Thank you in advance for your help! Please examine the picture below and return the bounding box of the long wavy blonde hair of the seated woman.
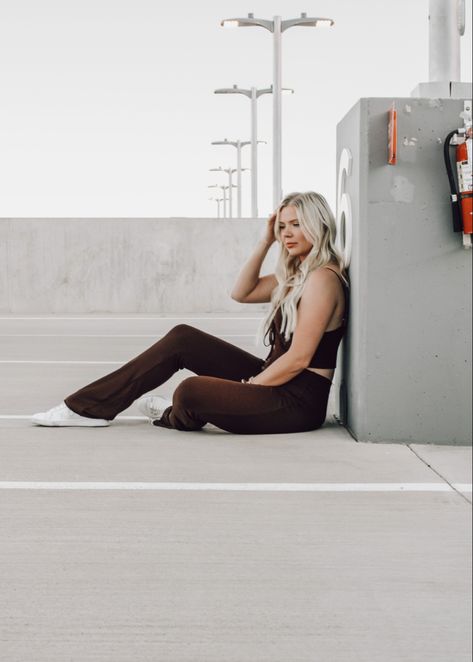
[257,191,349,344]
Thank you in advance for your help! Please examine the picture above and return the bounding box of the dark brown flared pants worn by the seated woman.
[65,324,331,434]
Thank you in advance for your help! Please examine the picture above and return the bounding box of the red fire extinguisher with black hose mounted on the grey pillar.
[443,102,473,248]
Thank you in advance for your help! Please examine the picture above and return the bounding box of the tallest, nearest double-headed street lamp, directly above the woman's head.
[220,13,335,207]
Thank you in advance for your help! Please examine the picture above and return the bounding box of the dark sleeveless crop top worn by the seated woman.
[263,267,349,369]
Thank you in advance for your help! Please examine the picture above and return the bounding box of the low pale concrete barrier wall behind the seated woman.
[0,218,279,314]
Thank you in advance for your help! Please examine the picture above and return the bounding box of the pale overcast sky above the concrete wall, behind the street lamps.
[0,0,472,217]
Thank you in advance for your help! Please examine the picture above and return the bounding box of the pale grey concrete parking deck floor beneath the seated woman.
[0,315,471,662]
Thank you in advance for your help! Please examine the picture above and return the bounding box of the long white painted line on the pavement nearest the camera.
[0,481,471,492]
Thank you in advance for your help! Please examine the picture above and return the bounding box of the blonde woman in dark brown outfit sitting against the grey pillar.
[32,192,349,434]
